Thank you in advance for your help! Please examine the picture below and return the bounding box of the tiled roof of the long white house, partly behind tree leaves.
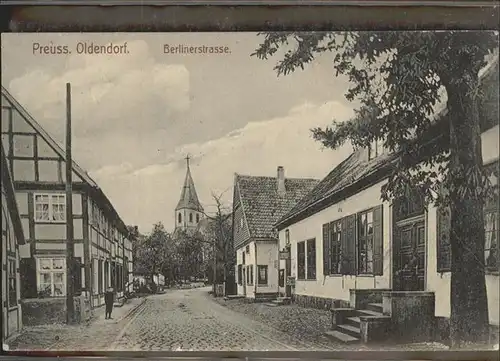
[276,58,498,228]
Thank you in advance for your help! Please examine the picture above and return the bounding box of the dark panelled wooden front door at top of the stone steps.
[393,220,425,291]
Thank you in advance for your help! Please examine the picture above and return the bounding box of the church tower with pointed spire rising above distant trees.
[175,156,204,233]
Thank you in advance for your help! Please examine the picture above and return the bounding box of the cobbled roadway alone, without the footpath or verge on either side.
[111,288,309,351]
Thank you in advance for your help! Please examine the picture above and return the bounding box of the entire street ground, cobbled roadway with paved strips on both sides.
[9,288,454,351]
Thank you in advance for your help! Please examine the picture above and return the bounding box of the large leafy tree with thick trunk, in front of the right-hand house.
[252,31,498,345]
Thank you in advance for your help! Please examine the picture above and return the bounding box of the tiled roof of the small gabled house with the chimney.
[235,174,319,238]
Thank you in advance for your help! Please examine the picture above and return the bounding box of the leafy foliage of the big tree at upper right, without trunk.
[252,31,498,208]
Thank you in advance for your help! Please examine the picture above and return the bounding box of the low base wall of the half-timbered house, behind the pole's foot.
[21,296,92,326]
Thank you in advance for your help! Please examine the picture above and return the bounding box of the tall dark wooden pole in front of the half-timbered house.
[66,83,75,324]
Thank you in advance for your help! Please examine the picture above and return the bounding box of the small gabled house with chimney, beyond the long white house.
[233,167,318,299]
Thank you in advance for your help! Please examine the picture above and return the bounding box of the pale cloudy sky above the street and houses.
[2,33,354,233]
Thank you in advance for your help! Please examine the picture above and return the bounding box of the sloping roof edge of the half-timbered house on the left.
[2,85,128,235]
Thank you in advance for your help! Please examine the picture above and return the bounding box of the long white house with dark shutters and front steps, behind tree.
[277,57,499,342]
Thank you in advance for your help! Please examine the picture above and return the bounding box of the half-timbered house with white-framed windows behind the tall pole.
[1,87,133,307]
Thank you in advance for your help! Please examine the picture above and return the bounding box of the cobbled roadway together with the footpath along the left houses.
[9,288,325,351]
